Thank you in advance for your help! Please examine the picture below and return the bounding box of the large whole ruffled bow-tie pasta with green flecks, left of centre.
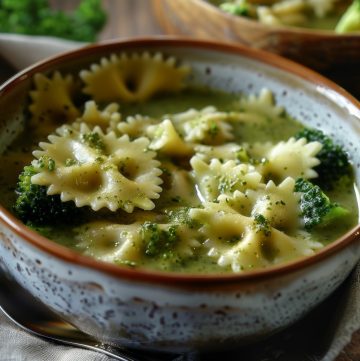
[31,123,162,213]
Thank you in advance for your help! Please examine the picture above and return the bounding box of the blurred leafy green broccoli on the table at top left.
[0,0,106,42]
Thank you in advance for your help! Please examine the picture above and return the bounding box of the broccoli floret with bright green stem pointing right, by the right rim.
[294,178,349,230]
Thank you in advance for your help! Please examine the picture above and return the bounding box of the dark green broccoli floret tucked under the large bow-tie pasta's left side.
[14,165,81,227]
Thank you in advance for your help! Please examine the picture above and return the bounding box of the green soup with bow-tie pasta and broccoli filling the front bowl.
[4,53,357,273]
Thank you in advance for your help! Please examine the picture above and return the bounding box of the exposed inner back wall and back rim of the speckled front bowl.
[0,39,360,282]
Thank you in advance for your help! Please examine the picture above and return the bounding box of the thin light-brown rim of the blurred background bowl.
[193,0,360,40]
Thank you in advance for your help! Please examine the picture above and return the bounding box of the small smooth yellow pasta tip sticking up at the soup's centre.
[146,119,193,157]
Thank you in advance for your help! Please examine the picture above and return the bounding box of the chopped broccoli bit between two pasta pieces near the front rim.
[140,222,179,259]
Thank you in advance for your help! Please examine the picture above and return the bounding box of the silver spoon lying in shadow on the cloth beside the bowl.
[0,273,179,361]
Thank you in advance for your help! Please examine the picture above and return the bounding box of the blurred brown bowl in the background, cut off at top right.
[153,0,360,71]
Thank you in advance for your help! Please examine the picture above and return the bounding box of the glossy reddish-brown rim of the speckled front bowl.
[0,36,360,287]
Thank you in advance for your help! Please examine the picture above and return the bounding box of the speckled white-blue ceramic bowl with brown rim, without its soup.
[0,39,360,351]
